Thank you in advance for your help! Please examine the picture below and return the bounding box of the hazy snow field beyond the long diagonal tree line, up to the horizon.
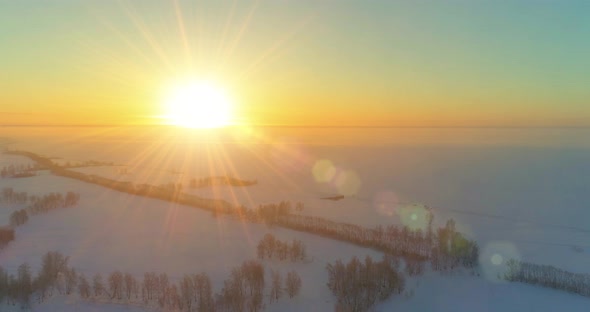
[53,146,590,272]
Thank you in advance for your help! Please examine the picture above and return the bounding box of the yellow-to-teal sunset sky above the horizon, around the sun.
[0,0,590,127]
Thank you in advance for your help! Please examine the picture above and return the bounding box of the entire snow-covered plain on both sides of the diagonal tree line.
[0,126,590,311]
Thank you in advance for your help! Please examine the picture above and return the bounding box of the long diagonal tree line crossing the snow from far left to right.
[5,152,479,274]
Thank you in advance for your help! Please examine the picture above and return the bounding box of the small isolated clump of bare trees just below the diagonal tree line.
[256,233,307,262]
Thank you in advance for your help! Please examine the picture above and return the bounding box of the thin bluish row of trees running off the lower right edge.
[504,259,590,297]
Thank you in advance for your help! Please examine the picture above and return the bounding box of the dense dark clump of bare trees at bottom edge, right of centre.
[326,256,405,312]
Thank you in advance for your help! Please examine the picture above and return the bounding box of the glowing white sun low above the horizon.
[164,81,232,128]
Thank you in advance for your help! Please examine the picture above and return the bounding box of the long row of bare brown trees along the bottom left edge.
[0,252,301,312]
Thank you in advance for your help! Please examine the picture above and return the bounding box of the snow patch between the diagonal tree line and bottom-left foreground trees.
[0,175,380,311]
